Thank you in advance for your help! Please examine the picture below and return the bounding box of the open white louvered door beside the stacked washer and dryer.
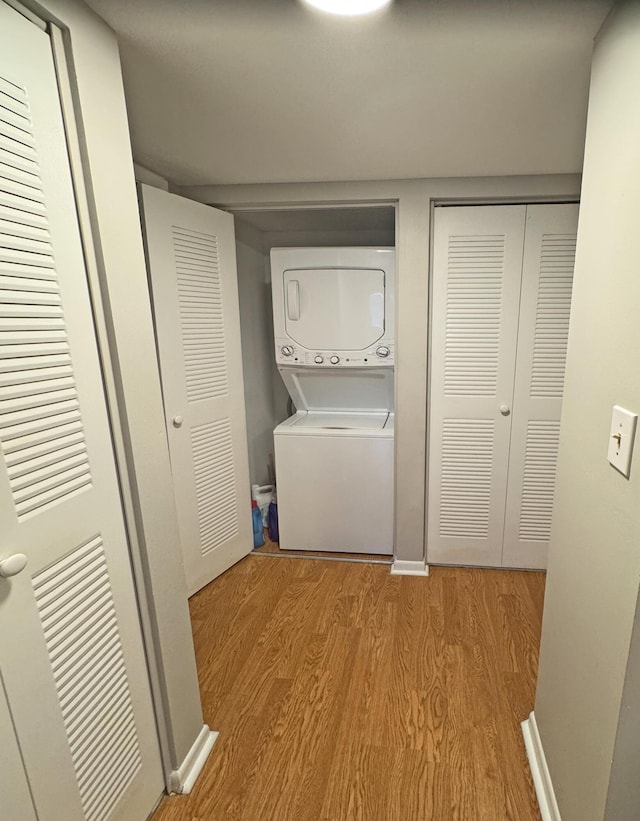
[141,185,253,594]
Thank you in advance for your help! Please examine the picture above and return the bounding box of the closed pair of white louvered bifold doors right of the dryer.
[427,204,578,568]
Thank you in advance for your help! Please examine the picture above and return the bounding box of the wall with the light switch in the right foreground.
[535,1,640,821]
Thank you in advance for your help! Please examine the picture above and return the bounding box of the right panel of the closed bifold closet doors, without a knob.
[502,204,578,568]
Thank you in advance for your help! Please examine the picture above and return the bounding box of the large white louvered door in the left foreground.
[0,3,163,821]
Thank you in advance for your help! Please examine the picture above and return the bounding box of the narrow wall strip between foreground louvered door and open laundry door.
[26,0,202,780]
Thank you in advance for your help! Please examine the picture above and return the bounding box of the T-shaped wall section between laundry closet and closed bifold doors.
[177,175,579,561]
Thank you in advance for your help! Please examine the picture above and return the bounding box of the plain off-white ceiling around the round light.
[86,0,612,185]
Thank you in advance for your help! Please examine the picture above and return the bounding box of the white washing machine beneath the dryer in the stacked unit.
[274,369,394,555]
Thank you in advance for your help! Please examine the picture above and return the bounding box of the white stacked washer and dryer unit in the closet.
[271,248,395,554]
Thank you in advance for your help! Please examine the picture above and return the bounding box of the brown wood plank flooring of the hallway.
[153,555,544,821]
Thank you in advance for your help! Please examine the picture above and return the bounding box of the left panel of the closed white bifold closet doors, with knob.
[427,206,526,566]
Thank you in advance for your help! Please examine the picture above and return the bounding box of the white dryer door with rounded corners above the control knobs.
[283,268,385,351]
